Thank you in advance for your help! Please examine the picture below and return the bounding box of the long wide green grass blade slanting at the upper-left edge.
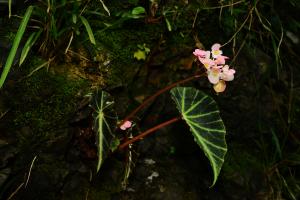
[0,6,33,88]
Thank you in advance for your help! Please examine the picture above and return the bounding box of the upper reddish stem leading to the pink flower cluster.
[119,73,205,127]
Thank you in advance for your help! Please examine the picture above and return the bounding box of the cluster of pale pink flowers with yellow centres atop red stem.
[193,44,235,92]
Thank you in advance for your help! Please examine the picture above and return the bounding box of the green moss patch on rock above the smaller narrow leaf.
[96,21,161,85]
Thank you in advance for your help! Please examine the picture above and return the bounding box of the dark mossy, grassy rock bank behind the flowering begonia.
[0,0,300,200]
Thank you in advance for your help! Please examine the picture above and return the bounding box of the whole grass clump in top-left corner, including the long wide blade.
[0,1,104,88]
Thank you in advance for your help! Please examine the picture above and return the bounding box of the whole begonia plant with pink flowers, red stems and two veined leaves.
[91,43,235,186]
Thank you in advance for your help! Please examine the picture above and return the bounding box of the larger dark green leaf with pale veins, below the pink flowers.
[171,87,227,186]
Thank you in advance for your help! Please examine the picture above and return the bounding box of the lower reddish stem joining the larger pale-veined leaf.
[119,117,181,149]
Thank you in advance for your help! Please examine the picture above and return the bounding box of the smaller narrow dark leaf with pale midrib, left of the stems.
[91,91,117,172]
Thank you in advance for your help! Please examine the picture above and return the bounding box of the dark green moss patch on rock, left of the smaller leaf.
[12,57,88,148]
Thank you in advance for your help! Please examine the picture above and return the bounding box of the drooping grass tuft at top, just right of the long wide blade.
[20,0,100,64]
